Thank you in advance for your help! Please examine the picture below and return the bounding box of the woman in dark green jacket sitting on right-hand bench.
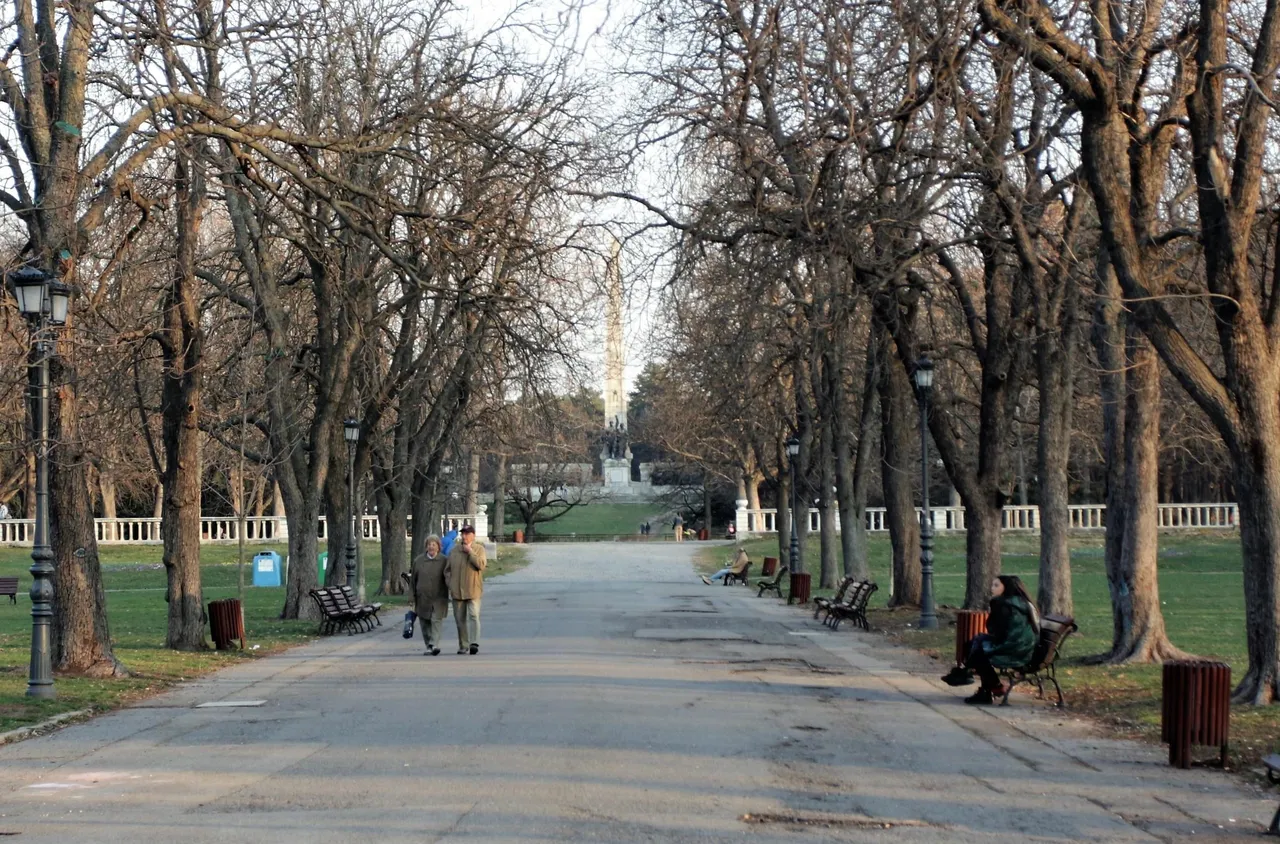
[942,575,1039,703]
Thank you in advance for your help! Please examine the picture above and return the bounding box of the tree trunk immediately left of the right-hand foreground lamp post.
[878,336,920,607]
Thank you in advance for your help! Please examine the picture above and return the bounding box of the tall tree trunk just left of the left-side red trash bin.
[160,154,207,651]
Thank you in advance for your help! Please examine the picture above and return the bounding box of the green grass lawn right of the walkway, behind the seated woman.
[701,532,1280,767]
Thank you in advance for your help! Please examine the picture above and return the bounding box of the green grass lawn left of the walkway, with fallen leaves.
[0,543,527,733]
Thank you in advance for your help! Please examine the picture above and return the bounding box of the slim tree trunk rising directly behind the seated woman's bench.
[1036,308,1075,616]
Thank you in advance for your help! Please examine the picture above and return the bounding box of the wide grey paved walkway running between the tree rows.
[0,543,1274,844]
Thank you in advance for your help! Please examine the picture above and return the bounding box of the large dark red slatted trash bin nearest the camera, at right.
[1160,660,1231,768]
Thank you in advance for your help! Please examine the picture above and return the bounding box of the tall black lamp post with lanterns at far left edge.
[9,266,72,698]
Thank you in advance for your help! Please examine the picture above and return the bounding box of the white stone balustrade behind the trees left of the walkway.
[0,505,489,546]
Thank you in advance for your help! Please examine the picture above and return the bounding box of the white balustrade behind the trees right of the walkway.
[735,501,1240,534]
